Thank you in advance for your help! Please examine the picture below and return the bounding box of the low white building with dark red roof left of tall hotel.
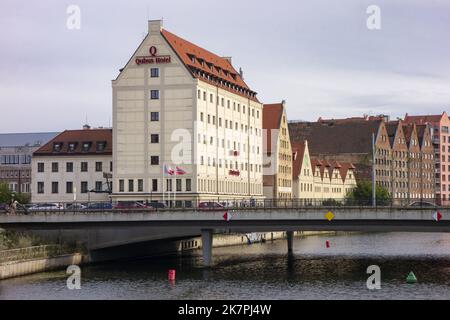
[31,126,113,203]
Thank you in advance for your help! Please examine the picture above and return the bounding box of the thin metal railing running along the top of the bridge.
[0,197,441,214]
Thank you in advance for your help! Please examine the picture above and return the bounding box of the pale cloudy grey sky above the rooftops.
[0,0,450,133]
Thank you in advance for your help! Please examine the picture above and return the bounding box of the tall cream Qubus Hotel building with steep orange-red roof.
[112,20,263,206]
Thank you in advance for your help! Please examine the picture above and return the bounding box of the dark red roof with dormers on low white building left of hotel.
[33,129,112,156]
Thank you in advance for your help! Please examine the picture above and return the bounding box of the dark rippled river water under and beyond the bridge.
[0,233,450,300]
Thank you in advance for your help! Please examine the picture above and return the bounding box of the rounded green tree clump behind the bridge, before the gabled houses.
[345,181,391,205]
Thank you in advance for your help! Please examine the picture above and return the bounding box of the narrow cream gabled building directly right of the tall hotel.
[263,101,292,199]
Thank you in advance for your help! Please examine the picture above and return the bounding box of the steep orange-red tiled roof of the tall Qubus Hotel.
[161,29,258,101]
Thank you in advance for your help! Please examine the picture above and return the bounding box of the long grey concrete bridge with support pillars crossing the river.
[0,206,450,266]
